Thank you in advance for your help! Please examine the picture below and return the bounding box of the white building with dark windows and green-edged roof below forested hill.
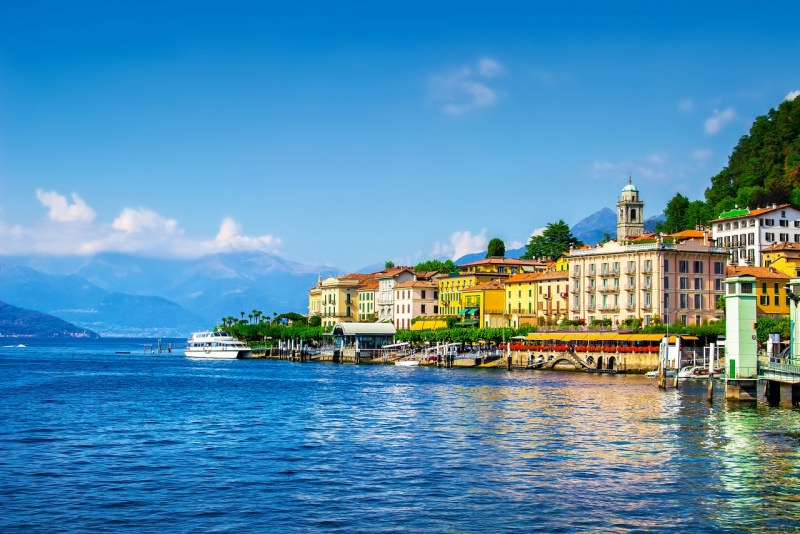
[711,204,800,266]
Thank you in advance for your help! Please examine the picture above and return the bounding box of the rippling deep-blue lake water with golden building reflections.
[0,339,800,532]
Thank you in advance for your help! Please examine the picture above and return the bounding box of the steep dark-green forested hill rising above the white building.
[659,96,800,231]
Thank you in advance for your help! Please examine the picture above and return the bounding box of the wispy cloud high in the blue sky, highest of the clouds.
[431,58,504,115]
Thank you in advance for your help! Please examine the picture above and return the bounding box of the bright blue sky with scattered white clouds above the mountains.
[0,0,800,272]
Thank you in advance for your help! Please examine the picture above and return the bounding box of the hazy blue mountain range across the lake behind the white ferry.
[0,252,334,337]
